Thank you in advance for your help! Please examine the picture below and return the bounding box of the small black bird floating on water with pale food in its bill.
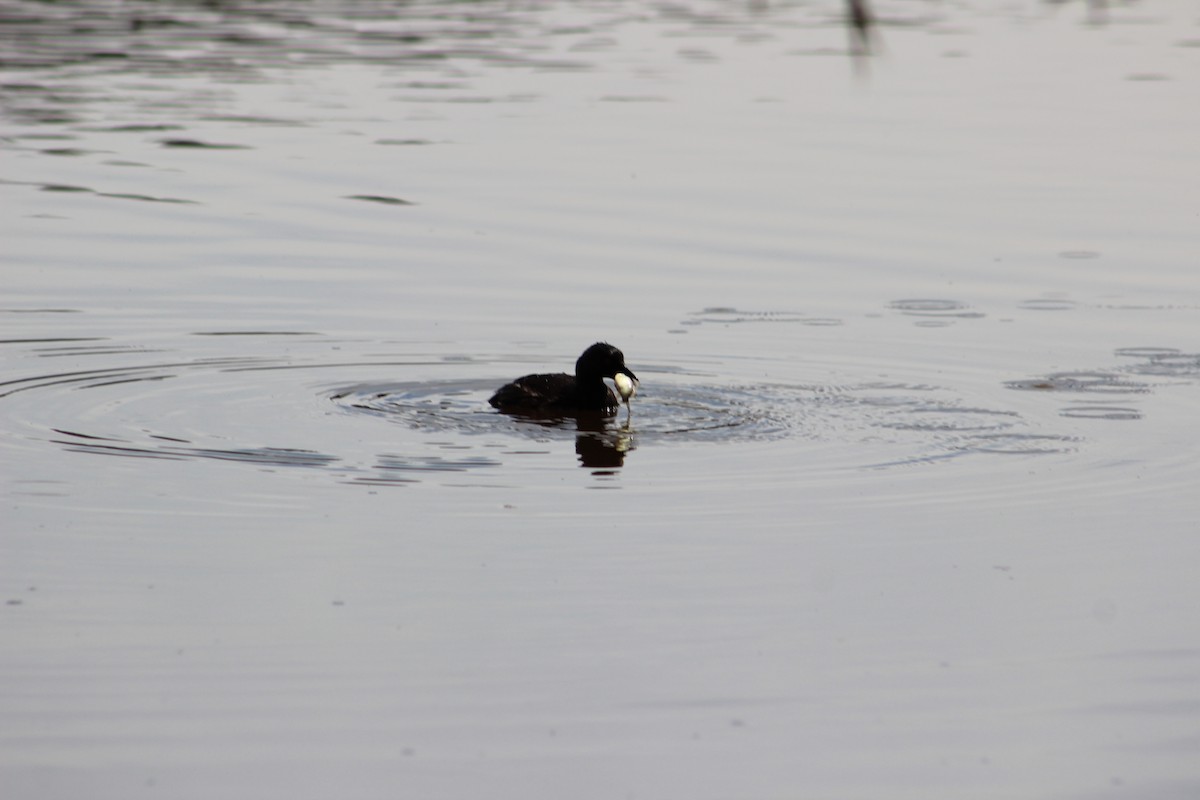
[487,342,637,414]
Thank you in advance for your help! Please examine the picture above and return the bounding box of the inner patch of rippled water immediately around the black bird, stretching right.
[326,371,1078,468]
